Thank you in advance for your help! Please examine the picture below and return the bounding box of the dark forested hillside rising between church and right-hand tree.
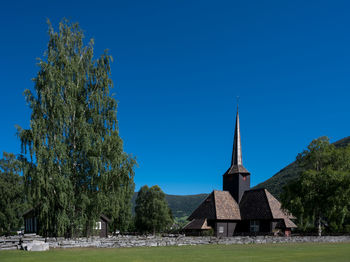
[254,136,350,198]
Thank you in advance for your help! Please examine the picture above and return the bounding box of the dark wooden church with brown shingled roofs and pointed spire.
[184,109,296,237]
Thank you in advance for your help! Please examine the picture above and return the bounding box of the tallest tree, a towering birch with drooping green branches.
[18,20,135,236]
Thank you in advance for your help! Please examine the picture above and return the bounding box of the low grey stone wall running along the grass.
[0,235,350,250]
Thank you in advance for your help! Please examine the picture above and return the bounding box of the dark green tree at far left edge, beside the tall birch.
[0,152,27,235]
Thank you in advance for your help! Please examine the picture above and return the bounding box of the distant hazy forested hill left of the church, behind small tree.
[132,192,208,218]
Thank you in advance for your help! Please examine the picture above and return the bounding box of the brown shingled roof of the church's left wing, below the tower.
[188,190,241,220]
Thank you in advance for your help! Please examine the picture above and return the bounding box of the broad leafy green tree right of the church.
[281,137,350,234]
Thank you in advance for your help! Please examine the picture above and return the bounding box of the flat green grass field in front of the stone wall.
[0,243,350,262]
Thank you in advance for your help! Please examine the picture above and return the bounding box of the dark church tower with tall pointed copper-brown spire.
[223,107,250,203]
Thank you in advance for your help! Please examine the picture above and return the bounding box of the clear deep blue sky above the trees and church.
[0,0,350,194]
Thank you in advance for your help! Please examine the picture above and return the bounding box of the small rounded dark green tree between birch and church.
[135,186,173,234]
